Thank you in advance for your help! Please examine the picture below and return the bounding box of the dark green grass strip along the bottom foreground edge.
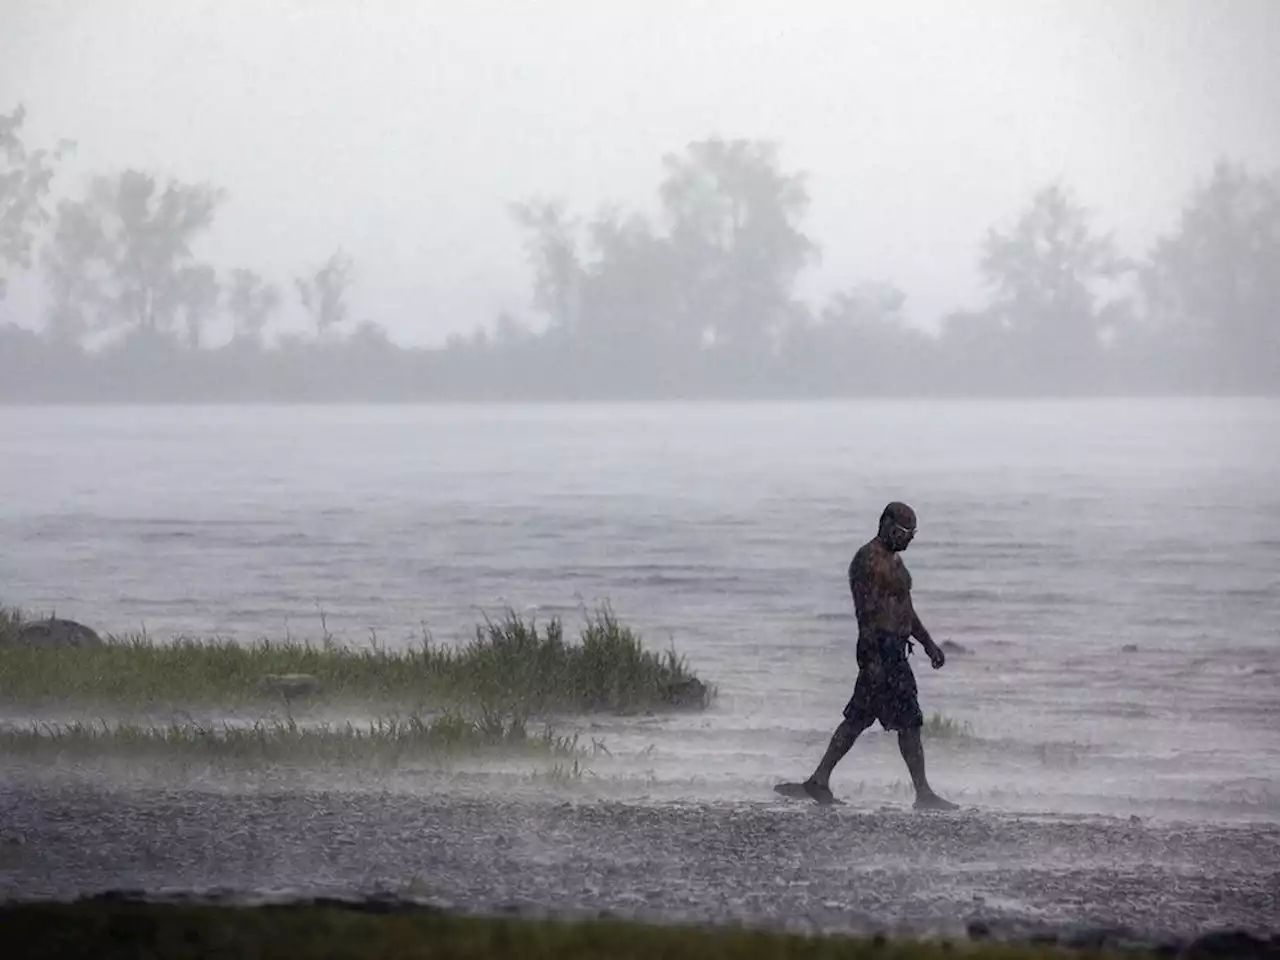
[0,899,1137,960]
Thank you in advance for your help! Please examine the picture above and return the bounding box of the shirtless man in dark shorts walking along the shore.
[804,503,959,810]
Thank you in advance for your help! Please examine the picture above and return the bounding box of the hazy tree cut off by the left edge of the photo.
[0,105,72,300]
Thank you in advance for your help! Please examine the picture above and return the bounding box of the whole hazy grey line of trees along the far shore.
[0,106,1280,401]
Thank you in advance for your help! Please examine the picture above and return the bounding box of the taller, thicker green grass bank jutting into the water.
[0,607,709,714]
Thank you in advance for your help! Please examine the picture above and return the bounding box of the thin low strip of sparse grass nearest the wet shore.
[0,713,581,767]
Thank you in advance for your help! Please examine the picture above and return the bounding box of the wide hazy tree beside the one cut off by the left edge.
[45,170,224,343]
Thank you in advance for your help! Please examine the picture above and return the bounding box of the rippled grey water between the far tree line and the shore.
[0,401,1280,820]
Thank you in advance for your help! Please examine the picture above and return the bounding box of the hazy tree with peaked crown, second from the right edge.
[979,183,1130,383]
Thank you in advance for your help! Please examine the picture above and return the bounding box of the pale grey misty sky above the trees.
[0,0,1280,343]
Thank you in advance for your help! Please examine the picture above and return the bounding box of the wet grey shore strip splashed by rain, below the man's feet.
[0,778,1280,942]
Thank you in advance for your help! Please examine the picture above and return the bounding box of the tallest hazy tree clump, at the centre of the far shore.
[511,138,817,372]
